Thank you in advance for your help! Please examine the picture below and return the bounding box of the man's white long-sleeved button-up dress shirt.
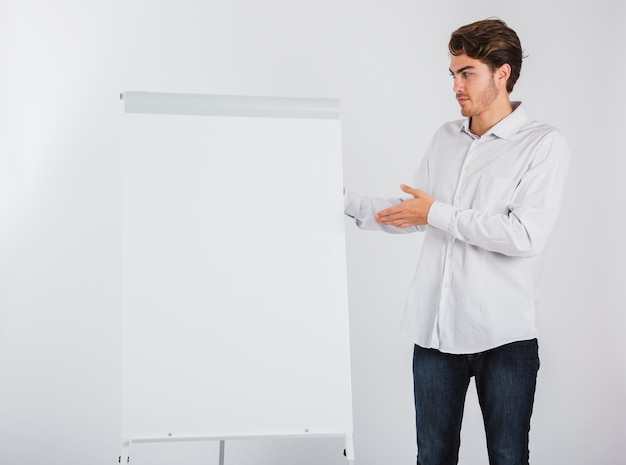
[345,102,569,354]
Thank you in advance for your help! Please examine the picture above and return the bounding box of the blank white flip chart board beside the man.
[122,92,352,440]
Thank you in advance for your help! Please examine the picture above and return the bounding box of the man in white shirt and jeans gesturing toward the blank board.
[345,19,569,465]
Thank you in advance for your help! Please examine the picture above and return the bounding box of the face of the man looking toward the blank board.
[450,55,500,116]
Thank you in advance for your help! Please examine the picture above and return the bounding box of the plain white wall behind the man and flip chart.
[0,0,626,465]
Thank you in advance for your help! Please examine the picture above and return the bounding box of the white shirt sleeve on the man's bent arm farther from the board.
[428,131,569,257]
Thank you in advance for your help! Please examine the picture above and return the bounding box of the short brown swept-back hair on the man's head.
[448,18,524,93]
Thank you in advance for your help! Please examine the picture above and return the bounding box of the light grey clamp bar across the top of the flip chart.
[120,91,339,119]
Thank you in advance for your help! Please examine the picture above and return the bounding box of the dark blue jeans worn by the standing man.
[413,339,539,465]
